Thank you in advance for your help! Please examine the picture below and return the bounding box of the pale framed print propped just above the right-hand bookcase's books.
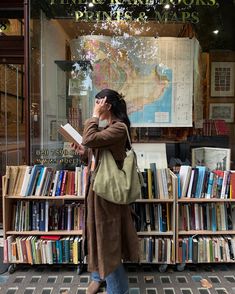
[192,147,231,170]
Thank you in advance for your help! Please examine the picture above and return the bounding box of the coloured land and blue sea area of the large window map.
[74,36,194,126]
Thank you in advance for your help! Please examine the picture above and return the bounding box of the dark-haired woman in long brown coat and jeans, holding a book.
[73,89,139,294]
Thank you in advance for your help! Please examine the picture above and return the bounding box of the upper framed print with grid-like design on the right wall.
[211,62,235,97]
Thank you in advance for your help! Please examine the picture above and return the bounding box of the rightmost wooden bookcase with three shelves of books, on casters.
[176,167,235,271]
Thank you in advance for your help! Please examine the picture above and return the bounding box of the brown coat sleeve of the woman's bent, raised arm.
[82,118,126,148]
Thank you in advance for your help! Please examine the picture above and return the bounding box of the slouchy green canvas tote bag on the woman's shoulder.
[93,124,143,204]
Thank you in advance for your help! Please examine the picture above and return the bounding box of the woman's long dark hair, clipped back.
[95,89,131,149]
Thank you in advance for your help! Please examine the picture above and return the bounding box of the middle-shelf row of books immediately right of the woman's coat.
[133,203,172,232]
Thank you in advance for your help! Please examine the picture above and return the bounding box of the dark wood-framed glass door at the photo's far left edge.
[0,64,25,223]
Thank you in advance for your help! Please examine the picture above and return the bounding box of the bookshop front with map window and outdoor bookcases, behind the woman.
[0,0,235,271]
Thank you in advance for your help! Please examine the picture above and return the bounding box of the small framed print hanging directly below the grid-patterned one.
[209,103,234,122]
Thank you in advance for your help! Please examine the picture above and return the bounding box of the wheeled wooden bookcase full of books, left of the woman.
[3,165,85,273]
